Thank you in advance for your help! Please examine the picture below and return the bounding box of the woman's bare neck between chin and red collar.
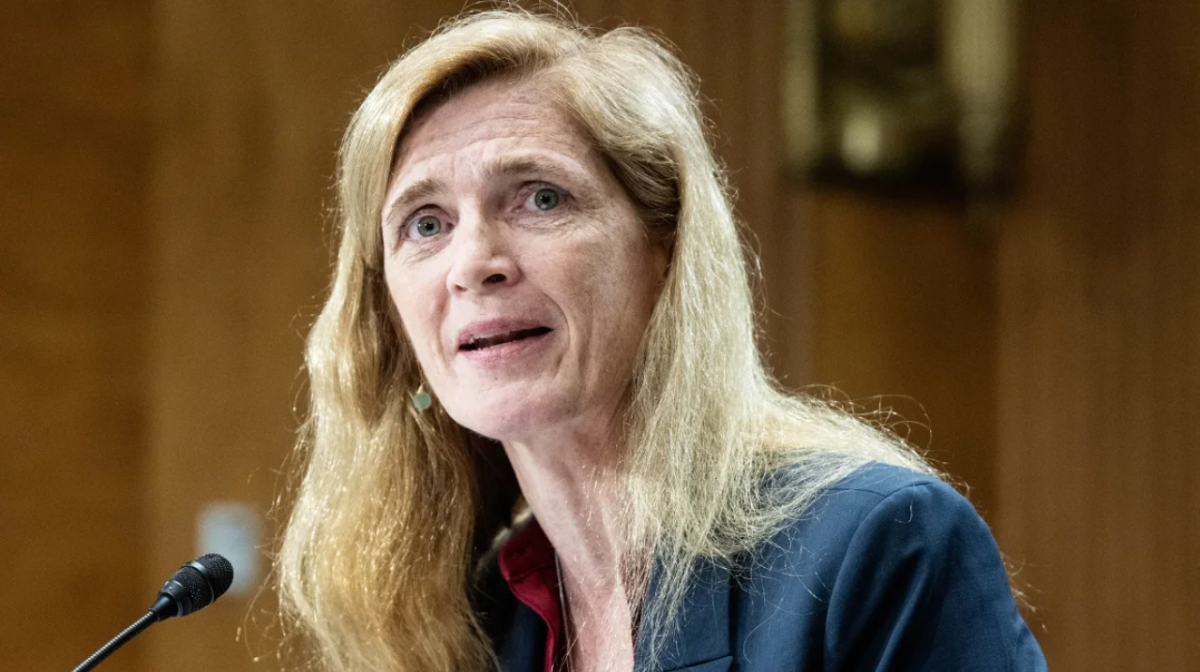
[504,420,632,672]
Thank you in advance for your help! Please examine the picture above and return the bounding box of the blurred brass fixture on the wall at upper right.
[782,0,1018,193]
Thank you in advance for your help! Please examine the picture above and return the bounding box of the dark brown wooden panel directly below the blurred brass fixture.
[801,190,997,513]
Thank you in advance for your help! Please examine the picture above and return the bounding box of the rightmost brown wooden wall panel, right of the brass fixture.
[997,0,1200,672]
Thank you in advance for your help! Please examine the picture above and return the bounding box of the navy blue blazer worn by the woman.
[485,464,1046,672]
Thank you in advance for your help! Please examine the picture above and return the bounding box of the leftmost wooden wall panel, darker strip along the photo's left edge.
[0,0,158,672]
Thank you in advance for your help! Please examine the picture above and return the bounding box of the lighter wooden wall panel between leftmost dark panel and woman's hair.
[146,0,458,672]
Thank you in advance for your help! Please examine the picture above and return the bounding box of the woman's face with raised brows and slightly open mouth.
[382,78,667,440]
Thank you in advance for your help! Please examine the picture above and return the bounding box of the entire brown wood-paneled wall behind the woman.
[0,0,1200,672]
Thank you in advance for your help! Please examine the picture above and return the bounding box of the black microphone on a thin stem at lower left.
[74,553,233,672]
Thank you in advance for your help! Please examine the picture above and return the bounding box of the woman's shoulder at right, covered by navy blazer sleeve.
[724,464,1044,670]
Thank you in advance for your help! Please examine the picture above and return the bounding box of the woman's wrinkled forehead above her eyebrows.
[392,79,599,186]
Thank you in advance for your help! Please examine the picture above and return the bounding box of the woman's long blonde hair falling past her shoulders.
[276,10,932,672]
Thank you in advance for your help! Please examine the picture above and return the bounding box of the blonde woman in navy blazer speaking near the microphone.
[278,6,1044,672]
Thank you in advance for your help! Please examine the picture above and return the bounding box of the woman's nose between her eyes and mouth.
[446,212,521,294]
